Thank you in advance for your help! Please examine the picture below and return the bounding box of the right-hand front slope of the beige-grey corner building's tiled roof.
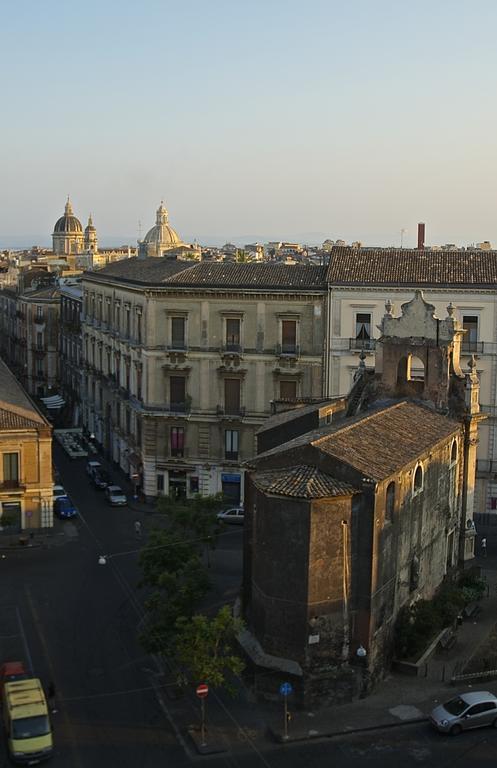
[168,262,327,291]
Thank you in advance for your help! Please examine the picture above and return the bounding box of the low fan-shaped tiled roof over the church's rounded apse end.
[252,464,357,499]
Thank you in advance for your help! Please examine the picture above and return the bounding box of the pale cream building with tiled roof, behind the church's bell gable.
[324,247,497,520]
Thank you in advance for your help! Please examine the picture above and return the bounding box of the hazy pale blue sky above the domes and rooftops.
[0,0,497,247]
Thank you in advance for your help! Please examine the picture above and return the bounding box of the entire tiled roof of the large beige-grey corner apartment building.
[84,257,327,291]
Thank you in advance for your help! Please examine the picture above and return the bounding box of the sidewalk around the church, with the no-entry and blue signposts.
[167,557,497,753]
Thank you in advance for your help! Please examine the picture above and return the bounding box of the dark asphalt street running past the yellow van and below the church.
[0,454,497,768]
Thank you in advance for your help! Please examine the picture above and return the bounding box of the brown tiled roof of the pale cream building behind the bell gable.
[327,247,497,288]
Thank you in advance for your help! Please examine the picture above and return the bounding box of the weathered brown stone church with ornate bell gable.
[242,291,482,705]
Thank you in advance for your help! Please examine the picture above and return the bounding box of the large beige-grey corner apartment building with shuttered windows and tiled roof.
[82,258,326,502]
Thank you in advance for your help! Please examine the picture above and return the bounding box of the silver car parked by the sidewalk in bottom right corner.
[430,691,497,736]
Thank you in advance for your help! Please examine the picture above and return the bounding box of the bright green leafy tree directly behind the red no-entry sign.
[175,605,245,692]
